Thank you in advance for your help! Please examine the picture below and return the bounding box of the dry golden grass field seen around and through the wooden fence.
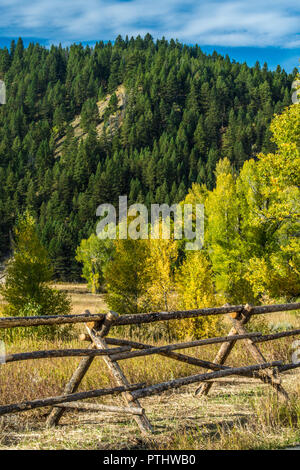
[0,284,300,450]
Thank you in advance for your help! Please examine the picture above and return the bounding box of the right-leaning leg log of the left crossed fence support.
[85,325,153,435]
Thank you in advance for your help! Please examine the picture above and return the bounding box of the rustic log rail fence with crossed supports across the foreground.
[0,303,300,433]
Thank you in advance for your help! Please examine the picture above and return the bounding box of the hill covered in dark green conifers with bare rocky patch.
[0,35,296,279]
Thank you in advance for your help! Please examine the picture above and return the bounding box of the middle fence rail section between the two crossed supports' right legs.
[111,333,261,361]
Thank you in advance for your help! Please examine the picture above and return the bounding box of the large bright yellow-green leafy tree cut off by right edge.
[240,104,300,299]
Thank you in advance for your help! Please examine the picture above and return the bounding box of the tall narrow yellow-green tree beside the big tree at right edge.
[205,158,252,303]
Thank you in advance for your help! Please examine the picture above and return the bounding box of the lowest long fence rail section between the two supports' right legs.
[131,361,282,399]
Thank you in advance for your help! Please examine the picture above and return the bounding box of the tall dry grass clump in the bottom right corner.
[161,385,300,450]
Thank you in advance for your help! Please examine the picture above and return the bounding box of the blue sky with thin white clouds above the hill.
[0,0,300,71]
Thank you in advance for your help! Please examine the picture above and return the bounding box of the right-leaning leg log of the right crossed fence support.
[231,318,289,400]
